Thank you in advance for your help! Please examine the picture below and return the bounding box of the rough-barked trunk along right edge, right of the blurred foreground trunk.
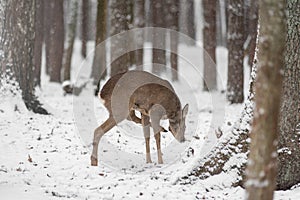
[272,0,300,190]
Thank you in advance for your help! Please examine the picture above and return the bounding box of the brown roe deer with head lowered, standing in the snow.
[91,71,188,166]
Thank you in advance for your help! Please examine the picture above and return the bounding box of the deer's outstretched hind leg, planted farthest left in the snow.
[91,116,116,166]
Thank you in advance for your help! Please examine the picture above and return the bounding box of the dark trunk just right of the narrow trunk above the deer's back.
[151,0,166,75]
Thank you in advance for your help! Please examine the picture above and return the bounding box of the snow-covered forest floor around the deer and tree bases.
[0,41,300,200]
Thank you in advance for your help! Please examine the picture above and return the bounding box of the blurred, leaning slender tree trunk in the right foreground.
[245,0,288,200]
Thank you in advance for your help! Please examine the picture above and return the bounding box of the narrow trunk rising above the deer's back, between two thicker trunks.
[134,0,145,70]
